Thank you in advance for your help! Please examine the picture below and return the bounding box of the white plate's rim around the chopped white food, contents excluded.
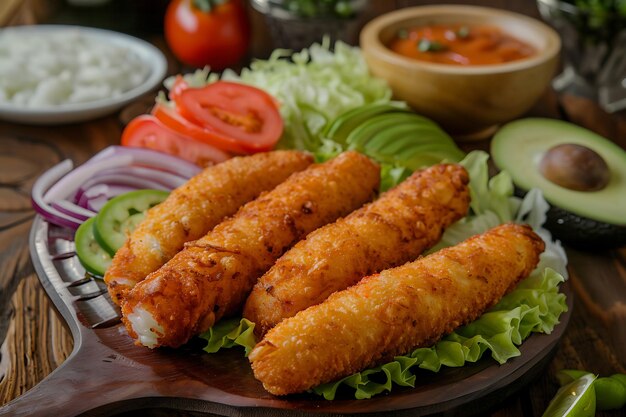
[0,25,167,125]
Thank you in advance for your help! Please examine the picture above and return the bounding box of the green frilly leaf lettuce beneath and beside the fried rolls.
[201,151,567,400]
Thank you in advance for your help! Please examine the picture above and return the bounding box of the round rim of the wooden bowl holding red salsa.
[360,4,561,75]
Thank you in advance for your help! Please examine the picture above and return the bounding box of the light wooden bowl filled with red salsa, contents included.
[360,5,561,140]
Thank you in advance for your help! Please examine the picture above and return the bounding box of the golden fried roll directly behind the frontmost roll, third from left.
[243,165,470,336]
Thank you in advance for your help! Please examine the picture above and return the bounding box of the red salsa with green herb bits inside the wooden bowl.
[389,24,536,65]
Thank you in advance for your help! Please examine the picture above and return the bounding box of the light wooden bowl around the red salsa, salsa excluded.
[360,5,561,140]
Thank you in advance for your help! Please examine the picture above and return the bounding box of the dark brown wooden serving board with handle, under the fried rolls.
[0,217,573,417]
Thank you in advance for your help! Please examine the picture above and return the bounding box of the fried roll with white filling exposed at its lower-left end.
[122,152,380,347]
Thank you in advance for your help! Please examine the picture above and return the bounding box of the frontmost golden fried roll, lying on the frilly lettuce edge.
[249,224,544,395]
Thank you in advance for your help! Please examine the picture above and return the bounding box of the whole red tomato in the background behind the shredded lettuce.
[165,0,250,70]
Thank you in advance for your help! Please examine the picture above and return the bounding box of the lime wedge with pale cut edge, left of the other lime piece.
[543,374,596,417]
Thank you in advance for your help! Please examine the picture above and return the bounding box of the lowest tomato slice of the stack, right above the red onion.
[122,114,230,167]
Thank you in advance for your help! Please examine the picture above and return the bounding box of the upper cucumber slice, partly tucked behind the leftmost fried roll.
[94,190,169,256]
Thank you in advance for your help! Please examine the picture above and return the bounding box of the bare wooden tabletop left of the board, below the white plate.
[0,127,114,404]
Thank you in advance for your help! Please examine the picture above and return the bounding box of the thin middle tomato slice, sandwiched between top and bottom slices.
[152,103,250,154]
